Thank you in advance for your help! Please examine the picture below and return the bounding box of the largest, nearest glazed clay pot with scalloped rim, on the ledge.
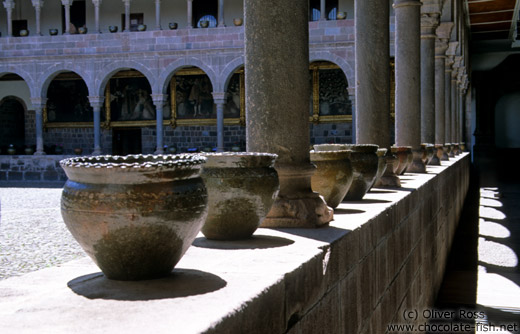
[60,155,207,280]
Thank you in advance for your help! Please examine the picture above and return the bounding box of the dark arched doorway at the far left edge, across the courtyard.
[0,97,25,154]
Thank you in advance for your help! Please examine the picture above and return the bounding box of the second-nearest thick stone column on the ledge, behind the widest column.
[353,0,401,187]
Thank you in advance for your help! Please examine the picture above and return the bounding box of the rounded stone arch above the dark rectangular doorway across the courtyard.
[95,60,156,96]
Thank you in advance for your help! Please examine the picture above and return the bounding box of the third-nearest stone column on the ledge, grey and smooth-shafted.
[394,0,426,173]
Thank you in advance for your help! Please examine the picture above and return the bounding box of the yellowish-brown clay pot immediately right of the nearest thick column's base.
[310,150,353,208]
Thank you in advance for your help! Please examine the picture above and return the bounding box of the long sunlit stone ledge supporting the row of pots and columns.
[0,153,469,334]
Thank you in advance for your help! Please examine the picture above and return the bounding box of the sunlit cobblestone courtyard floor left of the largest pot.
[0,188,85,280]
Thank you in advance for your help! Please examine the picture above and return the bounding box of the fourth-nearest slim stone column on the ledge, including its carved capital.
[421,1,440,144]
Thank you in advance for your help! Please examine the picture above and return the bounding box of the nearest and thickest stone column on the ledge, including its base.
[244,0,333,227]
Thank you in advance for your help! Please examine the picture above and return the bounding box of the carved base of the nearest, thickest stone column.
[260,164,334,228]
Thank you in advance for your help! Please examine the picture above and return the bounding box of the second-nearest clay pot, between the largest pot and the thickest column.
[202,152,279,240]
